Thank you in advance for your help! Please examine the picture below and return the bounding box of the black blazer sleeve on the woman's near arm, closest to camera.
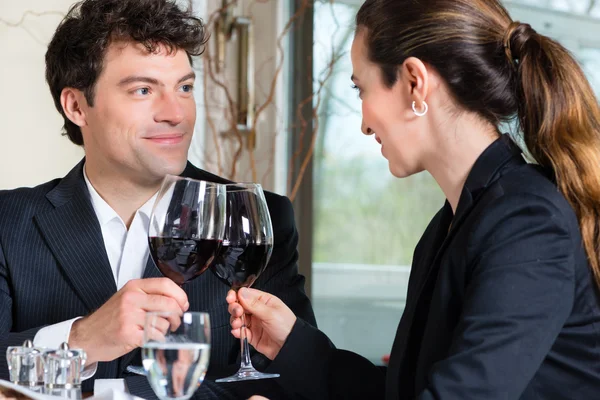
[418,194,577,400]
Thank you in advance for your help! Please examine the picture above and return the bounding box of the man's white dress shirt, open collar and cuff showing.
[33,166,157,379]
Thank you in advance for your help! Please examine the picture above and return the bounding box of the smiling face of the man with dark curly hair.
[81,41,196,184]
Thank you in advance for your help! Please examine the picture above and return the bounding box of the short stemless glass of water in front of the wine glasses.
[142,312,210,400]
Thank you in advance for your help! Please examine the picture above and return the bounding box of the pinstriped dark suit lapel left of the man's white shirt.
[35,161,117,311]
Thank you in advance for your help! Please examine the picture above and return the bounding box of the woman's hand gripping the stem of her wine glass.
[227,288,296,360]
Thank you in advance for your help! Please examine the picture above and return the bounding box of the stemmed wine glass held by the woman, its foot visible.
[210,183,279,382]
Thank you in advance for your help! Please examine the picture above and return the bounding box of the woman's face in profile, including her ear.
[351,29,429,178]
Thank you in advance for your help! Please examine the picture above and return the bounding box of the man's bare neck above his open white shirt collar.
[84,163,161,229]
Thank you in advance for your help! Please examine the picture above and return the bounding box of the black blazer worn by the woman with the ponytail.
[269,136,600,400]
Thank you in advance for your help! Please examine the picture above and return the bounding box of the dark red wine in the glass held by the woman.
[210,244,273,290]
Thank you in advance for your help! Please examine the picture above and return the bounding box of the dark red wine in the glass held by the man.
[148,237,221,285]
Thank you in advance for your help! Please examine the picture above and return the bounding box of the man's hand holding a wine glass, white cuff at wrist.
[69,278,189,364]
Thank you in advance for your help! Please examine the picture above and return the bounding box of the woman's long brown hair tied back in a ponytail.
[356,0,600,285]
